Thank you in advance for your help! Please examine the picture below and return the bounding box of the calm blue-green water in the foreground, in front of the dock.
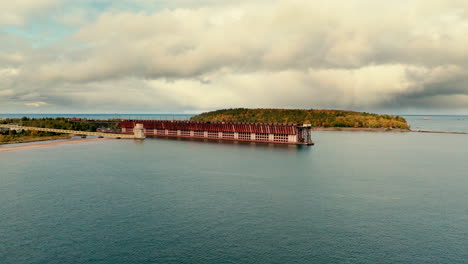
[0,132,468,264]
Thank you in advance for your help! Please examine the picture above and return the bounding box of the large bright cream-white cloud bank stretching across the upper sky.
[33,0,468,81]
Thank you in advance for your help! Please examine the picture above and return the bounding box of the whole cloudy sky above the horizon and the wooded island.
[0,0,468,114]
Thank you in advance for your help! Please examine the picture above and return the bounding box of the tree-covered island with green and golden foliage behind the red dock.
[191,108,409,129]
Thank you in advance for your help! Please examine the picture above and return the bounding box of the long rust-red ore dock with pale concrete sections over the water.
[120,120,313,145]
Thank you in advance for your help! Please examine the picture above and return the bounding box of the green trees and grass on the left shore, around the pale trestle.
[0,117,119,144]
